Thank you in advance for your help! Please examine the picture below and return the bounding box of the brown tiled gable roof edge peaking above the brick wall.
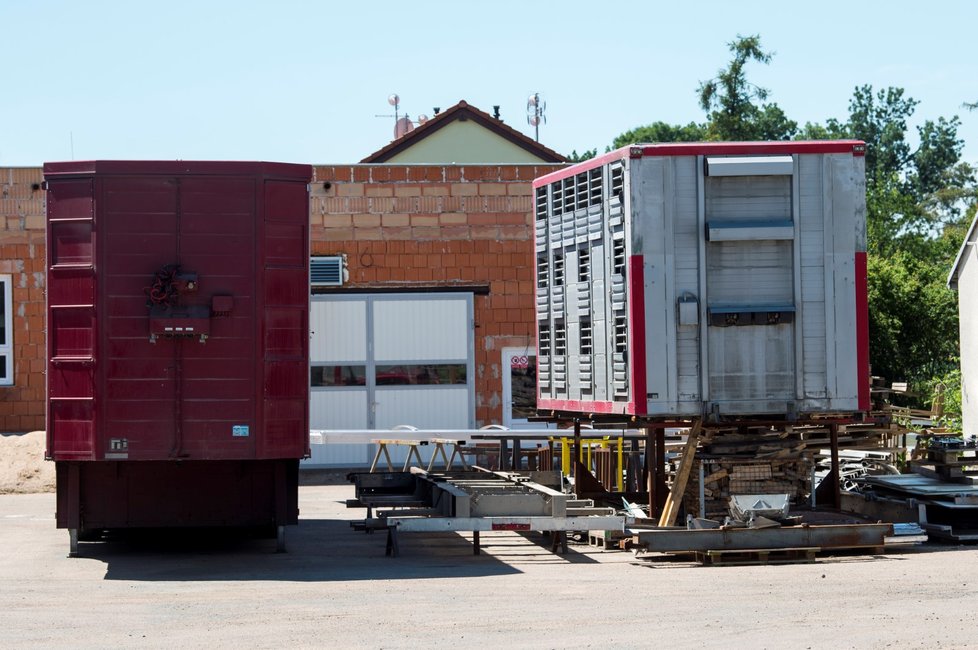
[360,99,568,163]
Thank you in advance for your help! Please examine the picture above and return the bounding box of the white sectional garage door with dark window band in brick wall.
[310,293,475,429]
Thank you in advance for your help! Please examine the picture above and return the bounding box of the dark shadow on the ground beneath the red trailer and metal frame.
[79,519,596,582]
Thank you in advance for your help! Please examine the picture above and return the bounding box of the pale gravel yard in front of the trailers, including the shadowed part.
[0,485,978,648]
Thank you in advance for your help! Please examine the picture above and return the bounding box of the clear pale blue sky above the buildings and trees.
[0,0,978,166]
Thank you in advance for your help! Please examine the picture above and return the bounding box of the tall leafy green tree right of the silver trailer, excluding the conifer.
[816,85,976,386]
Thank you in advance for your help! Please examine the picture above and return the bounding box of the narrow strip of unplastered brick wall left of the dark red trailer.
[0,167,45,433]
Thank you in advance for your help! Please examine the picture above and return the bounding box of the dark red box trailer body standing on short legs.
[44,161,311,553]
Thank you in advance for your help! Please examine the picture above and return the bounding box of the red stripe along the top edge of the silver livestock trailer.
[533,140,866,188]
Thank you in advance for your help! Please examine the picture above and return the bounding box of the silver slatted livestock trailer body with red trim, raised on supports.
[533,140,870,418]
